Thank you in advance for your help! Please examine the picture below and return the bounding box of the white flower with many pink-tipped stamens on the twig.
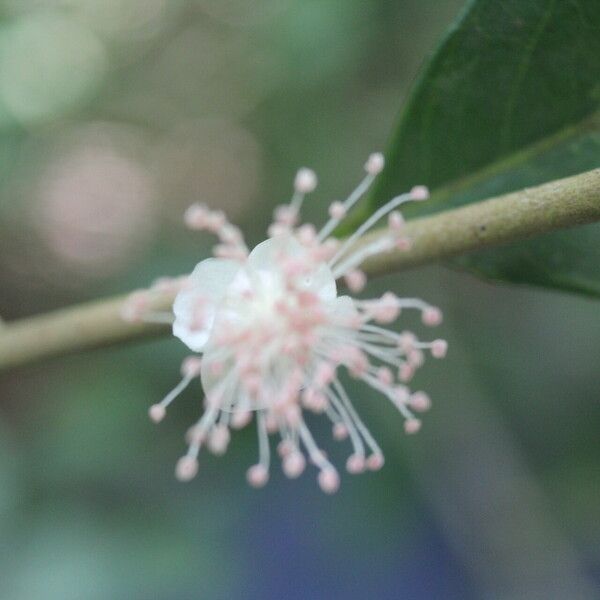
[125,154,446,492]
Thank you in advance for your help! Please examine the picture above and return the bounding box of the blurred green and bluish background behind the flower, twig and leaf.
[0,0,600,600]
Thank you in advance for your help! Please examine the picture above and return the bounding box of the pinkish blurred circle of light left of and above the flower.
[32,123,157,278]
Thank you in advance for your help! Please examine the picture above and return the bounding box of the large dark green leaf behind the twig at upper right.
[371,0,600,295]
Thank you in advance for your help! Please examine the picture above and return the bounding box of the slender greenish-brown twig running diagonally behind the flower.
[0,169,600,370]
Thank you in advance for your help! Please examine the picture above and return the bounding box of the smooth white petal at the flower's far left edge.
[173,258,241,352]
